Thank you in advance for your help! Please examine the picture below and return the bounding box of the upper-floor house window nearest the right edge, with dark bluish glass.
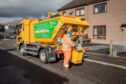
[94,2,107,14]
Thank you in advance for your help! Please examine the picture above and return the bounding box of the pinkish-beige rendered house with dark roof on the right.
[58,0,126,51]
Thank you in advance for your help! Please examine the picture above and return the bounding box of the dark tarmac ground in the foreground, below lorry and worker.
[0,39,126,84]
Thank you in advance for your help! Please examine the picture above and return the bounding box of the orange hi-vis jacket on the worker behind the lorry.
[62,35,74,51]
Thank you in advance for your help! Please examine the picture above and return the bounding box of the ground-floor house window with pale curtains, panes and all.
[93,25,106,39]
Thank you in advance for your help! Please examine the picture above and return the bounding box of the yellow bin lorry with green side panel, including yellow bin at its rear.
[16,16,89,64]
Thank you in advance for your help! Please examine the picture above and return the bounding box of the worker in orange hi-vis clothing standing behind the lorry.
[62,31,74,71]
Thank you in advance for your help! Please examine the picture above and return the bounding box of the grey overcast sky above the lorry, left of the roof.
[0,0,71,21]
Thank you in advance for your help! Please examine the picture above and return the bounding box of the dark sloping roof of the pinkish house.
[58,0,107,11]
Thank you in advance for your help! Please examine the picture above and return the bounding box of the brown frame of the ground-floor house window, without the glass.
[93,25,106,40]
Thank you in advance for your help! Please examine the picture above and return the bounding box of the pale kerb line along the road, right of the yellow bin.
[84,59,126,70]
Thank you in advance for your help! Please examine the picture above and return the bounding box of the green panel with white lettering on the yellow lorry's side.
[34,20,58,38]
